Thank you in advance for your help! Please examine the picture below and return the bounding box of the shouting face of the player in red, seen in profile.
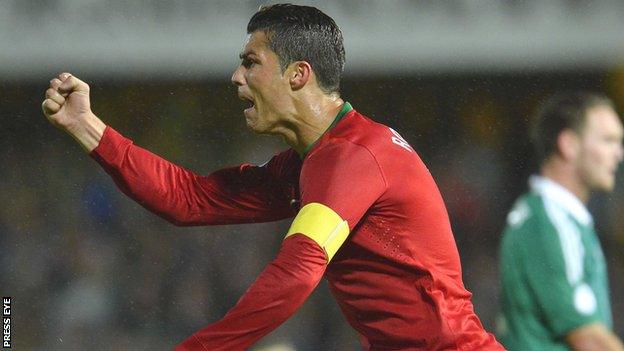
[232,31,289,133]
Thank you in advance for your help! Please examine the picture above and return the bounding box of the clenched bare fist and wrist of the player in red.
[41,73,106,152]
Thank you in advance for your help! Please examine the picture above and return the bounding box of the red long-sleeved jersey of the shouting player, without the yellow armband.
[92,103,503,351]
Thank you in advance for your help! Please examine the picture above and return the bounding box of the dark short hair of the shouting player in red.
[247,4,345,93]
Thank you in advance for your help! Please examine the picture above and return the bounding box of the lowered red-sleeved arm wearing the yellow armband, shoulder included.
[176,143,385,351]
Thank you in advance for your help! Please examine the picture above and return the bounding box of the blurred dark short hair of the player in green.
[530,91,614,165]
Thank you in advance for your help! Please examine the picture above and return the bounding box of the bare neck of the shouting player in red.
[276,95,344,156]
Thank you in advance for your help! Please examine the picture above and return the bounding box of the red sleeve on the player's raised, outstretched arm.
[91,127,294,225]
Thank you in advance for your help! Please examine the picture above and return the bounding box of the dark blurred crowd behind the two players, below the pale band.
[0,72,624,351]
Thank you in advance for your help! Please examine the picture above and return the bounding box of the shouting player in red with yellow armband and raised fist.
[43,5,502,351]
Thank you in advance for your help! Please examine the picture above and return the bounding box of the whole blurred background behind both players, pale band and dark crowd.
[0,0,624,351]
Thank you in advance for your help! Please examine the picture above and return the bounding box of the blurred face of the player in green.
[577,106,624,191]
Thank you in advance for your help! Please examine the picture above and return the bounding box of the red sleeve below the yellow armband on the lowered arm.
[175,235,327,351]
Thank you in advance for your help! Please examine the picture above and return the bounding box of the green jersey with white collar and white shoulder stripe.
[497,176,612,351]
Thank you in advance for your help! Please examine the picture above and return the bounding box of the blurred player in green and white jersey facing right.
[499,92,624,351]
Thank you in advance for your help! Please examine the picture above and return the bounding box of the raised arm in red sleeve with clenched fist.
[42,73,294,225]
